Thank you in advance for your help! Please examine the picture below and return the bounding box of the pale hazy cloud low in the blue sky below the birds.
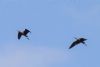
[0,45,68,67]
